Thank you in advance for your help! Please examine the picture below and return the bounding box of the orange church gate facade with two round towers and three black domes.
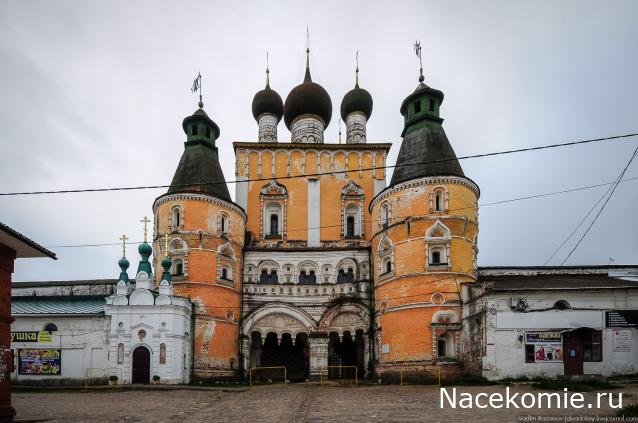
[153,51,479,380]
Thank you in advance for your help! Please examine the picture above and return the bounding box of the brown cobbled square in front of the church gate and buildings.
[13,384,638,423]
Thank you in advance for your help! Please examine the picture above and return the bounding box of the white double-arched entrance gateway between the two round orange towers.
[242,303,369,382]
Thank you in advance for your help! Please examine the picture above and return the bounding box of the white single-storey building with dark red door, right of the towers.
[461,266,638,380]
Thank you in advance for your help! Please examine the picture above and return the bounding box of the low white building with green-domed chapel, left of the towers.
[11,243,193,385]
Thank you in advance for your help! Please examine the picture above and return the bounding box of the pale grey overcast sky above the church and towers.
[0,0,638,280]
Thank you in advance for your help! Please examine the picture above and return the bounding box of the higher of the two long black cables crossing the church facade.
[0,133,638,196]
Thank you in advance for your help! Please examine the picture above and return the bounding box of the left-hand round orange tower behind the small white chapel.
[153,103,246,380]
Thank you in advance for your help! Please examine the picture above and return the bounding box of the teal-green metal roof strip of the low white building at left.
[11,295,106,316]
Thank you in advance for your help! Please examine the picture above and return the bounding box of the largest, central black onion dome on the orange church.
[284,68,332,129]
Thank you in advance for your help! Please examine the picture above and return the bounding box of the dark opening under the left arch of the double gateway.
[260,332,310,382]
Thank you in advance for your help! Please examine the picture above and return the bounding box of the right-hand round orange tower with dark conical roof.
[370,73,479,377]
